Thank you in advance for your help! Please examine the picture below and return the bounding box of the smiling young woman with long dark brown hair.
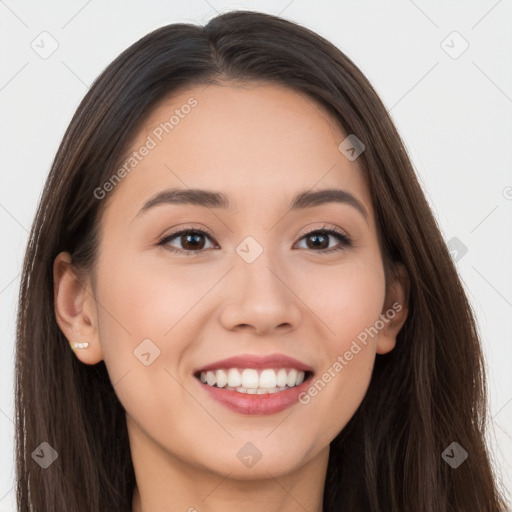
[15,8,505,512]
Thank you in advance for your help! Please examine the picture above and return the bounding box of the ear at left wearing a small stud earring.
[53,252,103,364]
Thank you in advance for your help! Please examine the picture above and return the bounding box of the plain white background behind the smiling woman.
[0,0,512,512]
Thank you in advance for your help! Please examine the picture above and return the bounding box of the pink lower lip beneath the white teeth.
[195,375,312,415]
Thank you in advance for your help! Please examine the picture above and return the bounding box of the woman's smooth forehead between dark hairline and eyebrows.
[106,82,372,221]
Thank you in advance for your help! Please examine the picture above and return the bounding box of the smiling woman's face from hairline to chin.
[56,83,408,479]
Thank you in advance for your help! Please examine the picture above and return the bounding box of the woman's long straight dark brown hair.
[15,11,505,512]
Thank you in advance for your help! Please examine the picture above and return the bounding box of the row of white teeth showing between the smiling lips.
[194,368,313,395]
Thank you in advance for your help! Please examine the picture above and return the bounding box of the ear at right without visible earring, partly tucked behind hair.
[377,263,410,354]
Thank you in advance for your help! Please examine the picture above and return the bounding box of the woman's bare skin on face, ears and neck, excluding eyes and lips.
[54,83,408,512]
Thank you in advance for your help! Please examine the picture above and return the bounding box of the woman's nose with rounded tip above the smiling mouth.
[220,251,302,335]
